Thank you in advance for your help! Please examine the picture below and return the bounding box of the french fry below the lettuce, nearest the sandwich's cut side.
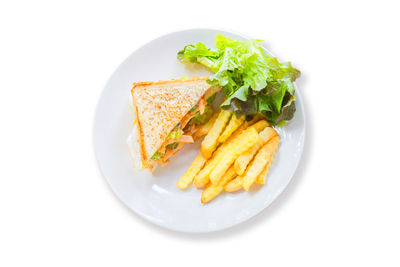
[201,110,232,159]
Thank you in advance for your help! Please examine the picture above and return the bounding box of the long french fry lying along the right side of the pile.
[243,136,279,190]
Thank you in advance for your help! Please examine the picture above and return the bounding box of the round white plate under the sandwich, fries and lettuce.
[94,29,305,232]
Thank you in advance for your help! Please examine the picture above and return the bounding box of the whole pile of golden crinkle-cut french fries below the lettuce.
[177,110,279,203]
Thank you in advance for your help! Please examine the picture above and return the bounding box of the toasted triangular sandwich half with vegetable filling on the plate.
[127,77,219,171]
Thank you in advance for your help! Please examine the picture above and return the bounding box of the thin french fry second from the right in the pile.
[234,127,278,175]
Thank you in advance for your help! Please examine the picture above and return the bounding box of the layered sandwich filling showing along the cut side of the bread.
[151,93,216,165]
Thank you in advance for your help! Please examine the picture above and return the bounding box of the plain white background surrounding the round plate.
[0,0,400,266]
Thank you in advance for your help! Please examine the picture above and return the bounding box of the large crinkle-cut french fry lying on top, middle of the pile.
[210,126,259,184]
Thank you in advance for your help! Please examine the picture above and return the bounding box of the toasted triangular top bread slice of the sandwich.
[131,77,211,169]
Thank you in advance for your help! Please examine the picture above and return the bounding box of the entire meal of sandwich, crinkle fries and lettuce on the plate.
[127,35,300,203]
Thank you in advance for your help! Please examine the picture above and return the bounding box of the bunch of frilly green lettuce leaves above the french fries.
[178,35,300,125]
